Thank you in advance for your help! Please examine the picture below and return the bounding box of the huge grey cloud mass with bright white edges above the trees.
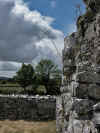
[0,0,63,77]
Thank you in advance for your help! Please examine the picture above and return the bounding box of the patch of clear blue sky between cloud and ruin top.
[24,0,85,36]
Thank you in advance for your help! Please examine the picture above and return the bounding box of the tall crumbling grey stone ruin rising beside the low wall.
[56,0,100,133]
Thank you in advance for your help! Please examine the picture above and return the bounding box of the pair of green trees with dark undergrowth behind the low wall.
[13,59,62,95]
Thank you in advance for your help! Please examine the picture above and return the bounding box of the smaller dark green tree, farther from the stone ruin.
[14,63,34,92]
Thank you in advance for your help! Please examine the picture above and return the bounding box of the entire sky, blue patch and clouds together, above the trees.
[0,0,84,77]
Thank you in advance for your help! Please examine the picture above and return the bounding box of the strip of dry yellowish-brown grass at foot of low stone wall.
[0,120,56,133]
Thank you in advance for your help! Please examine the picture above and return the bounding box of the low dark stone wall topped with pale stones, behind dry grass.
[0,95,56,121]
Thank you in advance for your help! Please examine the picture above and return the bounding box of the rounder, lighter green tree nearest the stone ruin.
[35,59,61,94]
